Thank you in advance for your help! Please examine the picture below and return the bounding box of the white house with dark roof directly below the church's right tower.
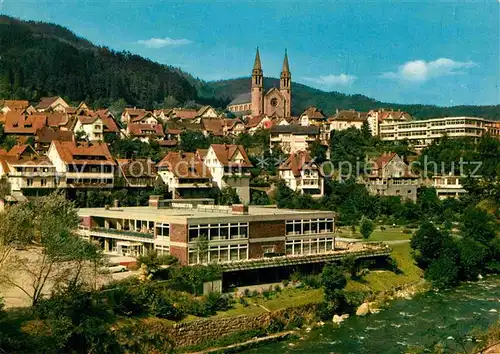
[270,124,320,153]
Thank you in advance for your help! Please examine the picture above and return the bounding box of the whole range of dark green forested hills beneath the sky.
[0,16,500,119]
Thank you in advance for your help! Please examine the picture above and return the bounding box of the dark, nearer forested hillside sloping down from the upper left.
[0,15,197,108]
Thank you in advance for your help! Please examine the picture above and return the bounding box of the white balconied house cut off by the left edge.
[0,145,60,201]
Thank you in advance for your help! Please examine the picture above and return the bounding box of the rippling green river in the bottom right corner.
[247,276,500,354]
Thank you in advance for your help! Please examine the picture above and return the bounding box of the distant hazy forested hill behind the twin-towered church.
[196,78,500,120]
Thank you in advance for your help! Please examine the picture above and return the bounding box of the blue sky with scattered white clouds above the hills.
[0,0,500,106]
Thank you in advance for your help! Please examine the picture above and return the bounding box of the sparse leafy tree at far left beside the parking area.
[0,192,101,306]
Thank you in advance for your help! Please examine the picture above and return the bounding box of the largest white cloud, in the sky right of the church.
[382,58,476,82]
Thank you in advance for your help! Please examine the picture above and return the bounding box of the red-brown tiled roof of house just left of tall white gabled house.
[156,151,212,178]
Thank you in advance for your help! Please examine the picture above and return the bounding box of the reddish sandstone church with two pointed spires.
[227,48,292,118]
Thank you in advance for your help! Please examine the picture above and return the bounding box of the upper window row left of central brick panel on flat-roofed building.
[189,222,248,241]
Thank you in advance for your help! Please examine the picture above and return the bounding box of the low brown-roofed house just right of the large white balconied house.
[115,159,157,188]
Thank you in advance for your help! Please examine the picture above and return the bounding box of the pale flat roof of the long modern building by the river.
[78,201,335,224]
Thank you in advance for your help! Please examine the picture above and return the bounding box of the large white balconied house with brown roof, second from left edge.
[47,140,116,188]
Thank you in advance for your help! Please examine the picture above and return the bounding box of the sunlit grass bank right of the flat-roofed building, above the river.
[346,243,422,292]
